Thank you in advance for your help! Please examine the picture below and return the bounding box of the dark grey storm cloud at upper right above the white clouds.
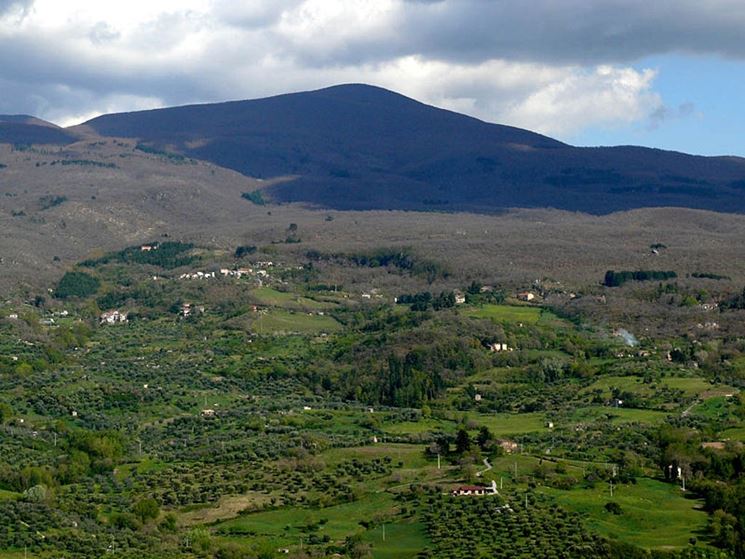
[284,0,745,65]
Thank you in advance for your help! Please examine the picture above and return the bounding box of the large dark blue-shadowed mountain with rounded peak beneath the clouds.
[80,85,745,214]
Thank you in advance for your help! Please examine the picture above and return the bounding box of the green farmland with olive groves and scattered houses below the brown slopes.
[0,244,745,559]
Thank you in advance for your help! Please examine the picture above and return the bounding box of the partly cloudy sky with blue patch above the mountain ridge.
[0,0,745,156]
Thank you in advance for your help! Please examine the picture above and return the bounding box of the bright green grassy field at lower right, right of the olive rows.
[541,478,707,549]
